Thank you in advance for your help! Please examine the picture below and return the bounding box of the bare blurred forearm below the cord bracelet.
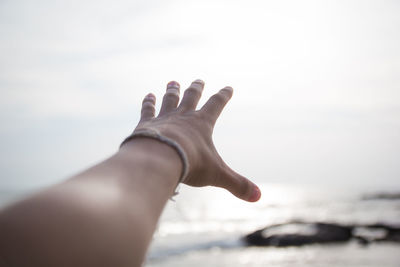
[0,138,182,266]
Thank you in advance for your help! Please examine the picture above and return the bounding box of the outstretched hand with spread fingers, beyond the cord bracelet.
[128,80,261,202]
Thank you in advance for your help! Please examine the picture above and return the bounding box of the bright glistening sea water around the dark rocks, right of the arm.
[145,184,400,267]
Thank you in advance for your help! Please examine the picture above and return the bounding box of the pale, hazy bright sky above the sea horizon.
[0,0,400,192]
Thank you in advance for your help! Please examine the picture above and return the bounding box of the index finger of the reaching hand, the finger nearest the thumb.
[200,86,233,124]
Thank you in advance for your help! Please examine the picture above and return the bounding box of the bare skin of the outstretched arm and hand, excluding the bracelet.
[0,80,261,267]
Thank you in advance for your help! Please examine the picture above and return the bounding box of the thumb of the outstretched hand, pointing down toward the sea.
[216,166,261,202]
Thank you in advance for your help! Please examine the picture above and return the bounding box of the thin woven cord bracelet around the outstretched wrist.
[119,129,189,196]
